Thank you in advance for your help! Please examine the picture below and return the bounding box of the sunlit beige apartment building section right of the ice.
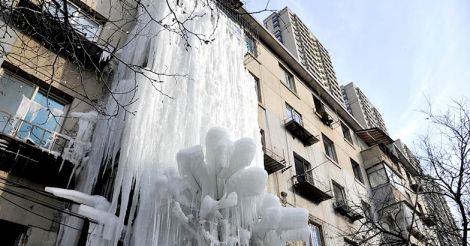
[245,7,439,246]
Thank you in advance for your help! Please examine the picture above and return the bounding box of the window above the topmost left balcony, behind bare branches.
[45,0,101,41]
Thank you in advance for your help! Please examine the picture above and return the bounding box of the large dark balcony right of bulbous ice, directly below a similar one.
[292,173,333,203]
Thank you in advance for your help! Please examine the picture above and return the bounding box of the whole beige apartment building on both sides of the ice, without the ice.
[0,0,456,246]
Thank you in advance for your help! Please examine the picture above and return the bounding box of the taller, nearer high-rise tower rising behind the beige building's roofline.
[264,7,344,105]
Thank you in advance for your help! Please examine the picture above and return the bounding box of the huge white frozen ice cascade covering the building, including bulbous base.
[47,0,309,246]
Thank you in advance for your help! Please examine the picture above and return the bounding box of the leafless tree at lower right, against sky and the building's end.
[342,99,470,246]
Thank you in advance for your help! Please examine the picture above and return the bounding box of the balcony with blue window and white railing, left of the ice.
[0,110,87,187]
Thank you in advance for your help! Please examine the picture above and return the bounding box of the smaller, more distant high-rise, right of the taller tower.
[341,82,387,133]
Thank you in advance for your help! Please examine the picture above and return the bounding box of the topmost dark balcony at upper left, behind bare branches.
[9,0,106,68]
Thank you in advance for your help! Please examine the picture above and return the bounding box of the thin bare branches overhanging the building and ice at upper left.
[0,0,269,116]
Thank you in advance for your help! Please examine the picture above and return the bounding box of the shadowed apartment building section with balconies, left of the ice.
[0,0,131,245]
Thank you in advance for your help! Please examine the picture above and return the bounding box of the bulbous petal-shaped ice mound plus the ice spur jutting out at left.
[46,128,309,246]
